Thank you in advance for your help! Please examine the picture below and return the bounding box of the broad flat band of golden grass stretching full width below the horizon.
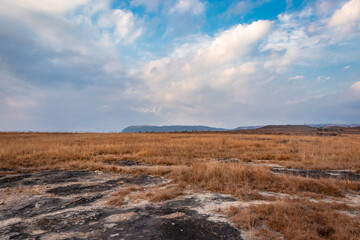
[0,133,360,170]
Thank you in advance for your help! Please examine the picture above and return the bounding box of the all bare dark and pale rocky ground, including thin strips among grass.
[0,158,360,239]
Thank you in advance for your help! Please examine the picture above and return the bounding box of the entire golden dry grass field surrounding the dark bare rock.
[0,133,360,239]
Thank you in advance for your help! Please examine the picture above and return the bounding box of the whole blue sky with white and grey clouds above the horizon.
[0,0,360,132]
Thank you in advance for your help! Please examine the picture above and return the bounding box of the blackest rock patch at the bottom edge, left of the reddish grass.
[93,201,241,240]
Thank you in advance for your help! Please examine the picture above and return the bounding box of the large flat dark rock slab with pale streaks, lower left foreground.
[0,171,241,240]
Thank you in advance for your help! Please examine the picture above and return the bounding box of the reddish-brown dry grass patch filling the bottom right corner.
[228,200,360,240]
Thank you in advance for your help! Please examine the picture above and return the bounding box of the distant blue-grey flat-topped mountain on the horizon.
[122,125,227,133]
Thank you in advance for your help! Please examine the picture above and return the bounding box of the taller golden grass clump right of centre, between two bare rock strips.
[170,162,354,198]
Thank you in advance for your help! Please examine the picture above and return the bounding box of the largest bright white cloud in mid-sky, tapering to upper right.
[131,21,272,116]
